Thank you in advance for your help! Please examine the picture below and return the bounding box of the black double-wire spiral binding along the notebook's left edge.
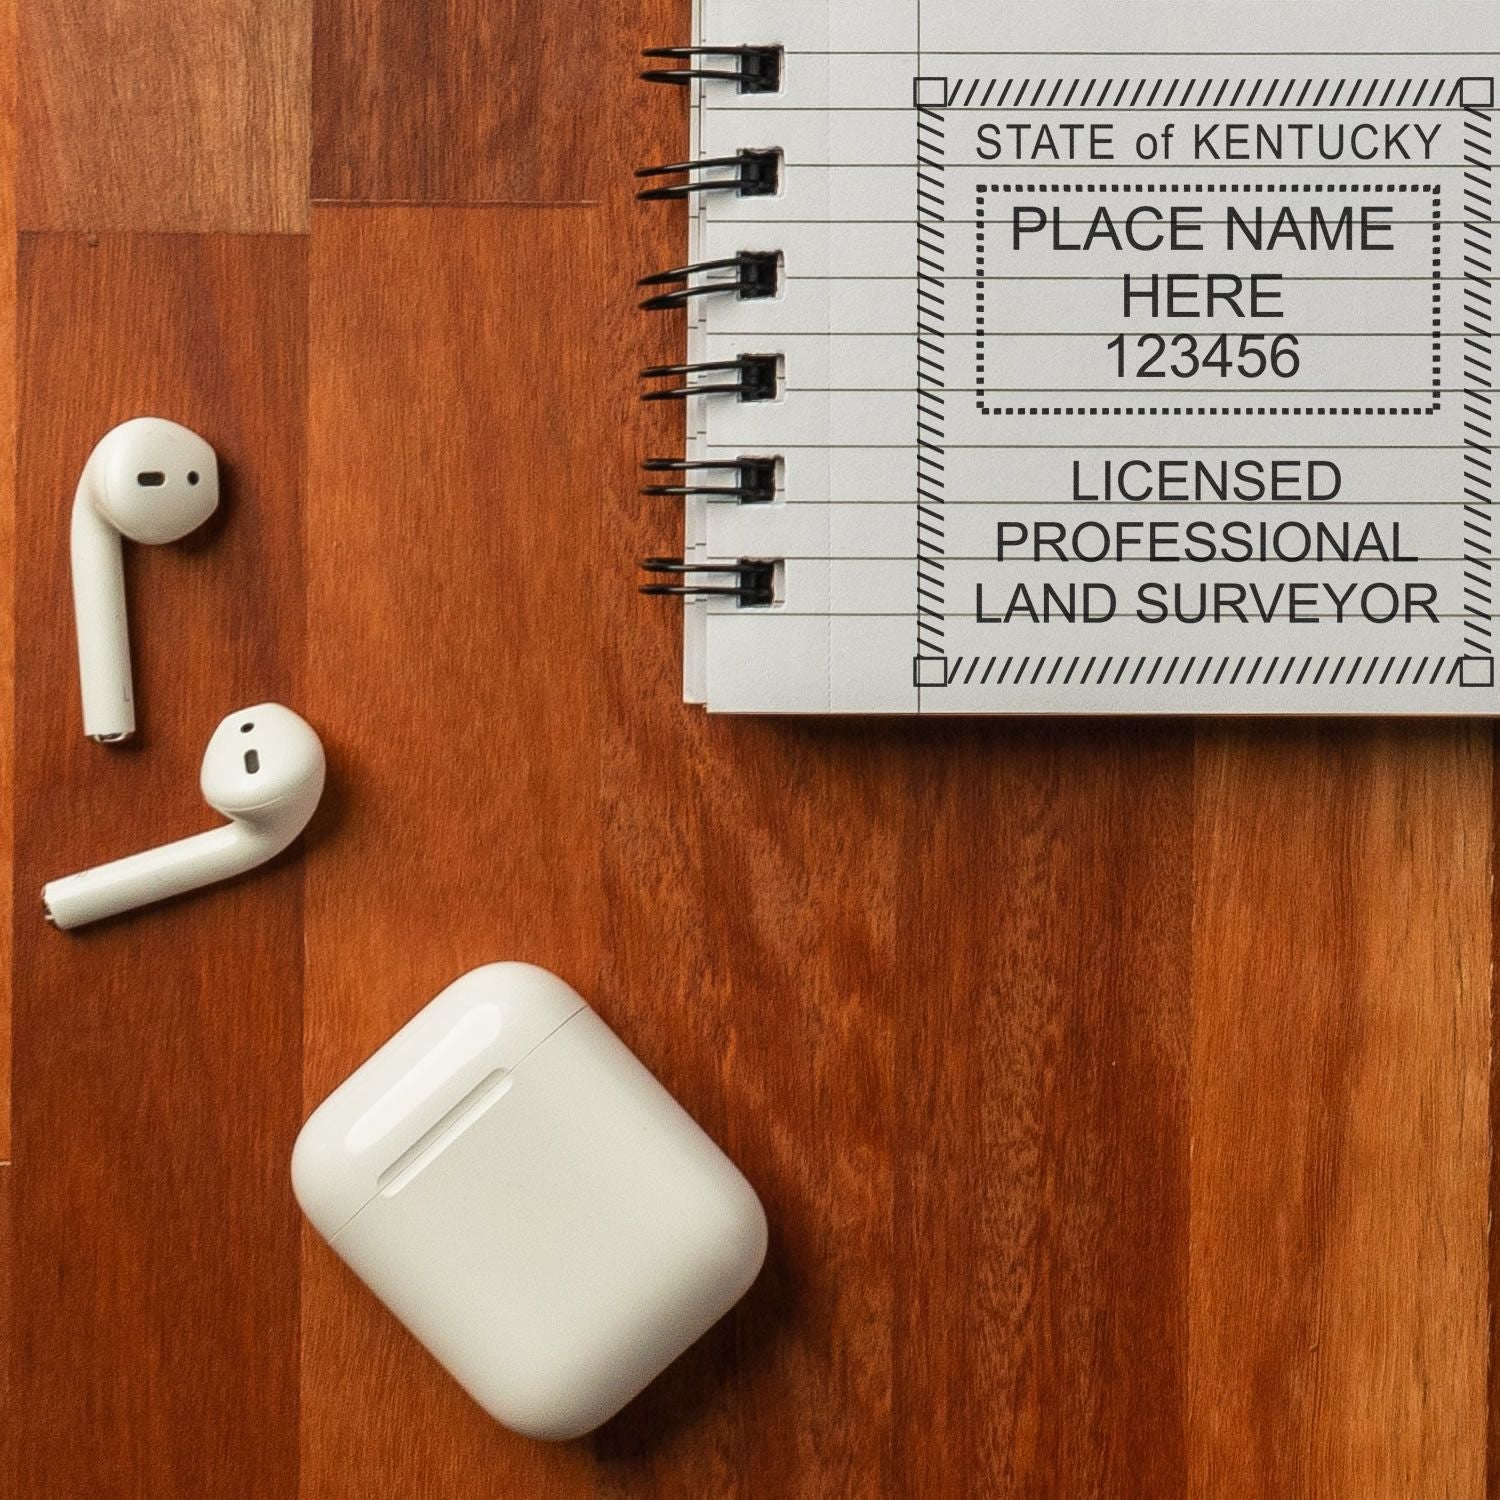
[636,45,783,608]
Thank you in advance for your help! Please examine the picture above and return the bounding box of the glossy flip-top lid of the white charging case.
[291,963,588,1239]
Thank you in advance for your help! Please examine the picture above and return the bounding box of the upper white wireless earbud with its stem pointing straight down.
[74,417,219,744]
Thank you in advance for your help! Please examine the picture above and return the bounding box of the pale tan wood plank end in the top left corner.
[20,0,312,233]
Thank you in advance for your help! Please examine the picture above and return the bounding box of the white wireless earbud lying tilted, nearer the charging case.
[42,704,326,927]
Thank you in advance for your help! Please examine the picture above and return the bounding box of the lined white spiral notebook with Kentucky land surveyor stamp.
[641,0,1500,714]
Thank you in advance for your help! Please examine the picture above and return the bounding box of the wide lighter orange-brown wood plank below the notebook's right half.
[1188,725,1491,1500]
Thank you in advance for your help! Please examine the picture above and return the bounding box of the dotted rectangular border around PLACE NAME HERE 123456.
[975,183,1443,417]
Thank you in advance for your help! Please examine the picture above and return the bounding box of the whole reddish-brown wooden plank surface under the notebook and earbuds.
[0,0,1496,1500]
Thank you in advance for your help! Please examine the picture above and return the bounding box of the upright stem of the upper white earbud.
[72,486,135,744]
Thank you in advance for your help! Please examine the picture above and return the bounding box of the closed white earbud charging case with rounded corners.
[291,963,767,1439]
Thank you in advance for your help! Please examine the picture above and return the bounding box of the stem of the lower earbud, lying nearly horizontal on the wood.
[42,822,282,927]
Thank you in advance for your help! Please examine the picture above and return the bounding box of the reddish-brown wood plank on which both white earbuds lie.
[14,236,318,1497]
